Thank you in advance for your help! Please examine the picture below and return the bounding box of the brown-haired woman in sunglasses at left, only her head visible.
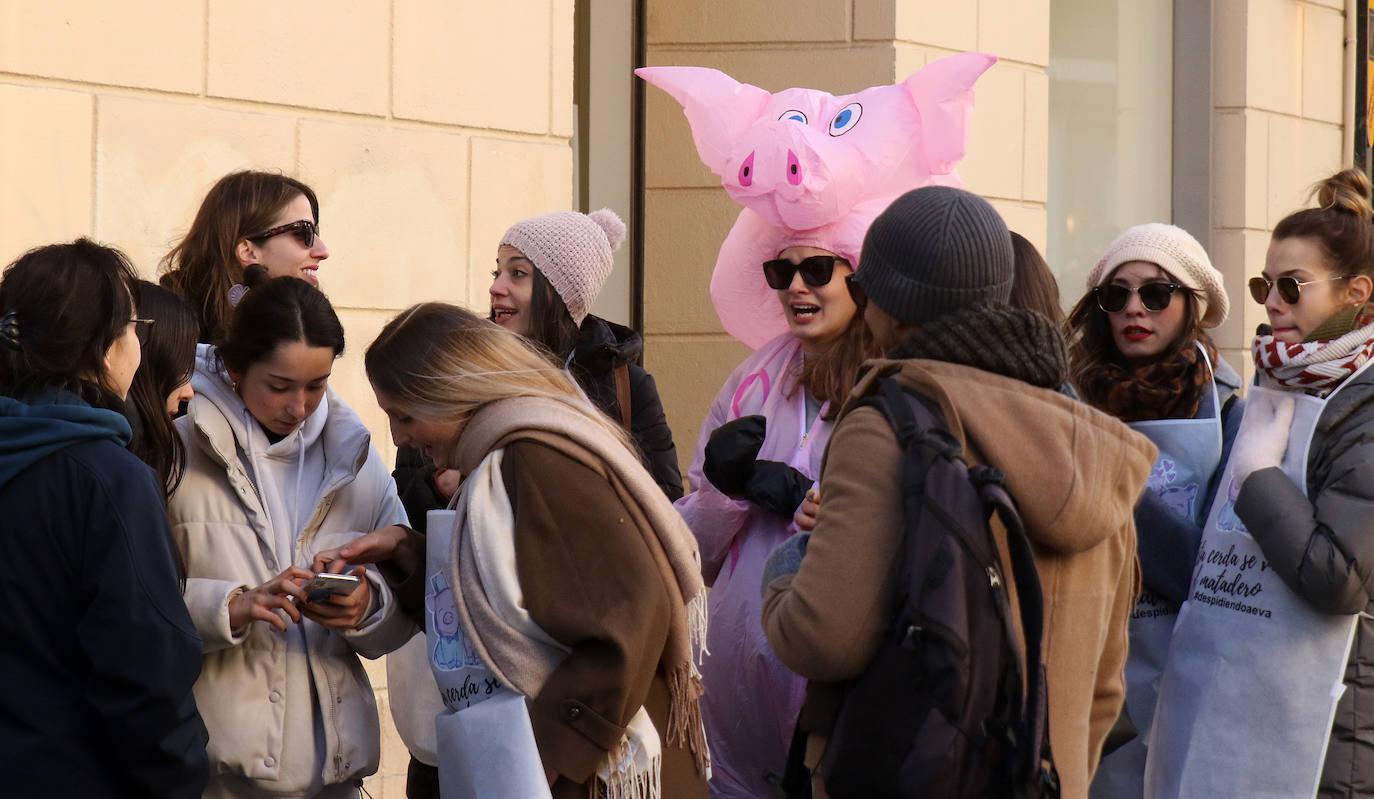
[162,170,330,343]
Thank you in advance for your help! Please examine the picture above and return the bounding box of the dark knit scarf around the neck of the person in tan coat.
[888,305,1069,389]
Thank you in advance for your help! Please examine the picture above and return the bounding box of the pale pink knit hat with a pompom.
[502,209,625,325]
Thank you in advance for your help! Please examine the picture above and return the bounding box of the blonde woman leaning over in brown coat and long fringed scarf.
[322,303,708,799]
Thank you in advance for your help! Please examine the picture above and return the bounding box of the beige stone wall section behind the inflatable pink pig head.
[644,0,1050,471]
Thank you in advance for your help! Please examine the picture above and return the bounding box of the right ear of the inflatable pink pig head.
[903,52,998,175]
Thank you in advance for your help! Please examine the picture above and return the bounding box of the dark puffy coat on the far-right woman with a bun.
[1235,371,1374,799]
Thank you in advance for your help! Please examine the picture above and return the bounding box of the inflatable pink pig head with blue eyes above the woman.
[635,52,998,349]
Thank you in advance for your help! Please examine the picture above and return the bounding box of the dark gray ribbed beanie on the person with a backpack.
[853,185,1015,324]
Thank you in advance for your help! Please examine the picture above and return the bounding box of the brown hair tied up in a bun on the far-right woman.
[1274,169,1374,277]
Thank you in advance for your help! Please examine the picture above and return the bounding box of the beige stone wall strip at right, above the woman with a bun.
[1210,0,1353,378]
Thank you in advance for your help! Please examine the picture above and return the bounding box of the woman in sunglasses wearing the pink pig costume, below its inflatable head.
[677,222,882,796]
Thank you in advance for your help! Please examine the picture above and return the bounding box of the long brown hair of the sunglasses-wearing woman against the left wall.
[161,170,320,345]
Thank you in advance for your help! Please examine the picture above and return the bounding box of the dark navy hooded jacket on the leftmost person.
[0,394,207,799]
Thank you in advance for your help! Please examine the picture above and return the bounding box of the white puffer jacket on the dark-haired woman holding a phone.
[169,346,415,795]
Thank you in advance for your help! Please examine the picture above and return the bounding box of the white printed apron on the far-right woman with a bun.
[1145,370,1374,799]
